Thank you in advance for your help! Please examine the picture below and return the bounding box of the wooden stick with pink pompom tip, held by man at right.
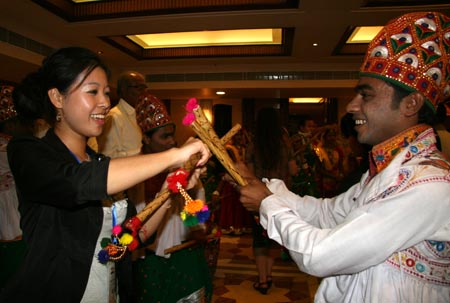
[183,98,247,186]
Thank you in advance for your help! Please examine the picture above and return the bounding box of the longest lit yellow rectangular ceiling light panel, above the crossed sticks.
[127,28,282,49]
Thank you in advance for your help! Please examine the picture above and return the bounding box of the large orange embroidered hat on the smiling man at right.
[360,12,450,110]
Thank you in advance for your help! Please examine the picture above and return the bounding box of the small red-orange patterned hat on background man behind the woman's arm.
[135,91,174,133]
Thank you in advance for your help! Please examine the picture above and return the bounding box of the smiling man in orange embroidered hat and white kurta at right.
[240,12,450,303]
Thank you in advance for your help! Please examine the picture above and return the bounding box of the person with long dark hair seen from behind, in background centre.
[246,108,289,294]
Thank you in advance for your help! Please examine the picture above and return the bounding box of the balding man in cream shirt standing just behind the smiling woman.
[97,71,147,211]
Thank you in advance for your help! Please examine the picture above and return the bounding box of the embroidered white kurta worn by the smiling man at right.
[260,129,450,303]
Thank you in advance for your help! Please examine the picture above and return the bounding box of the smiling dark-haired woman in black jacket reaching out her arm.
[0,47,210,302]
